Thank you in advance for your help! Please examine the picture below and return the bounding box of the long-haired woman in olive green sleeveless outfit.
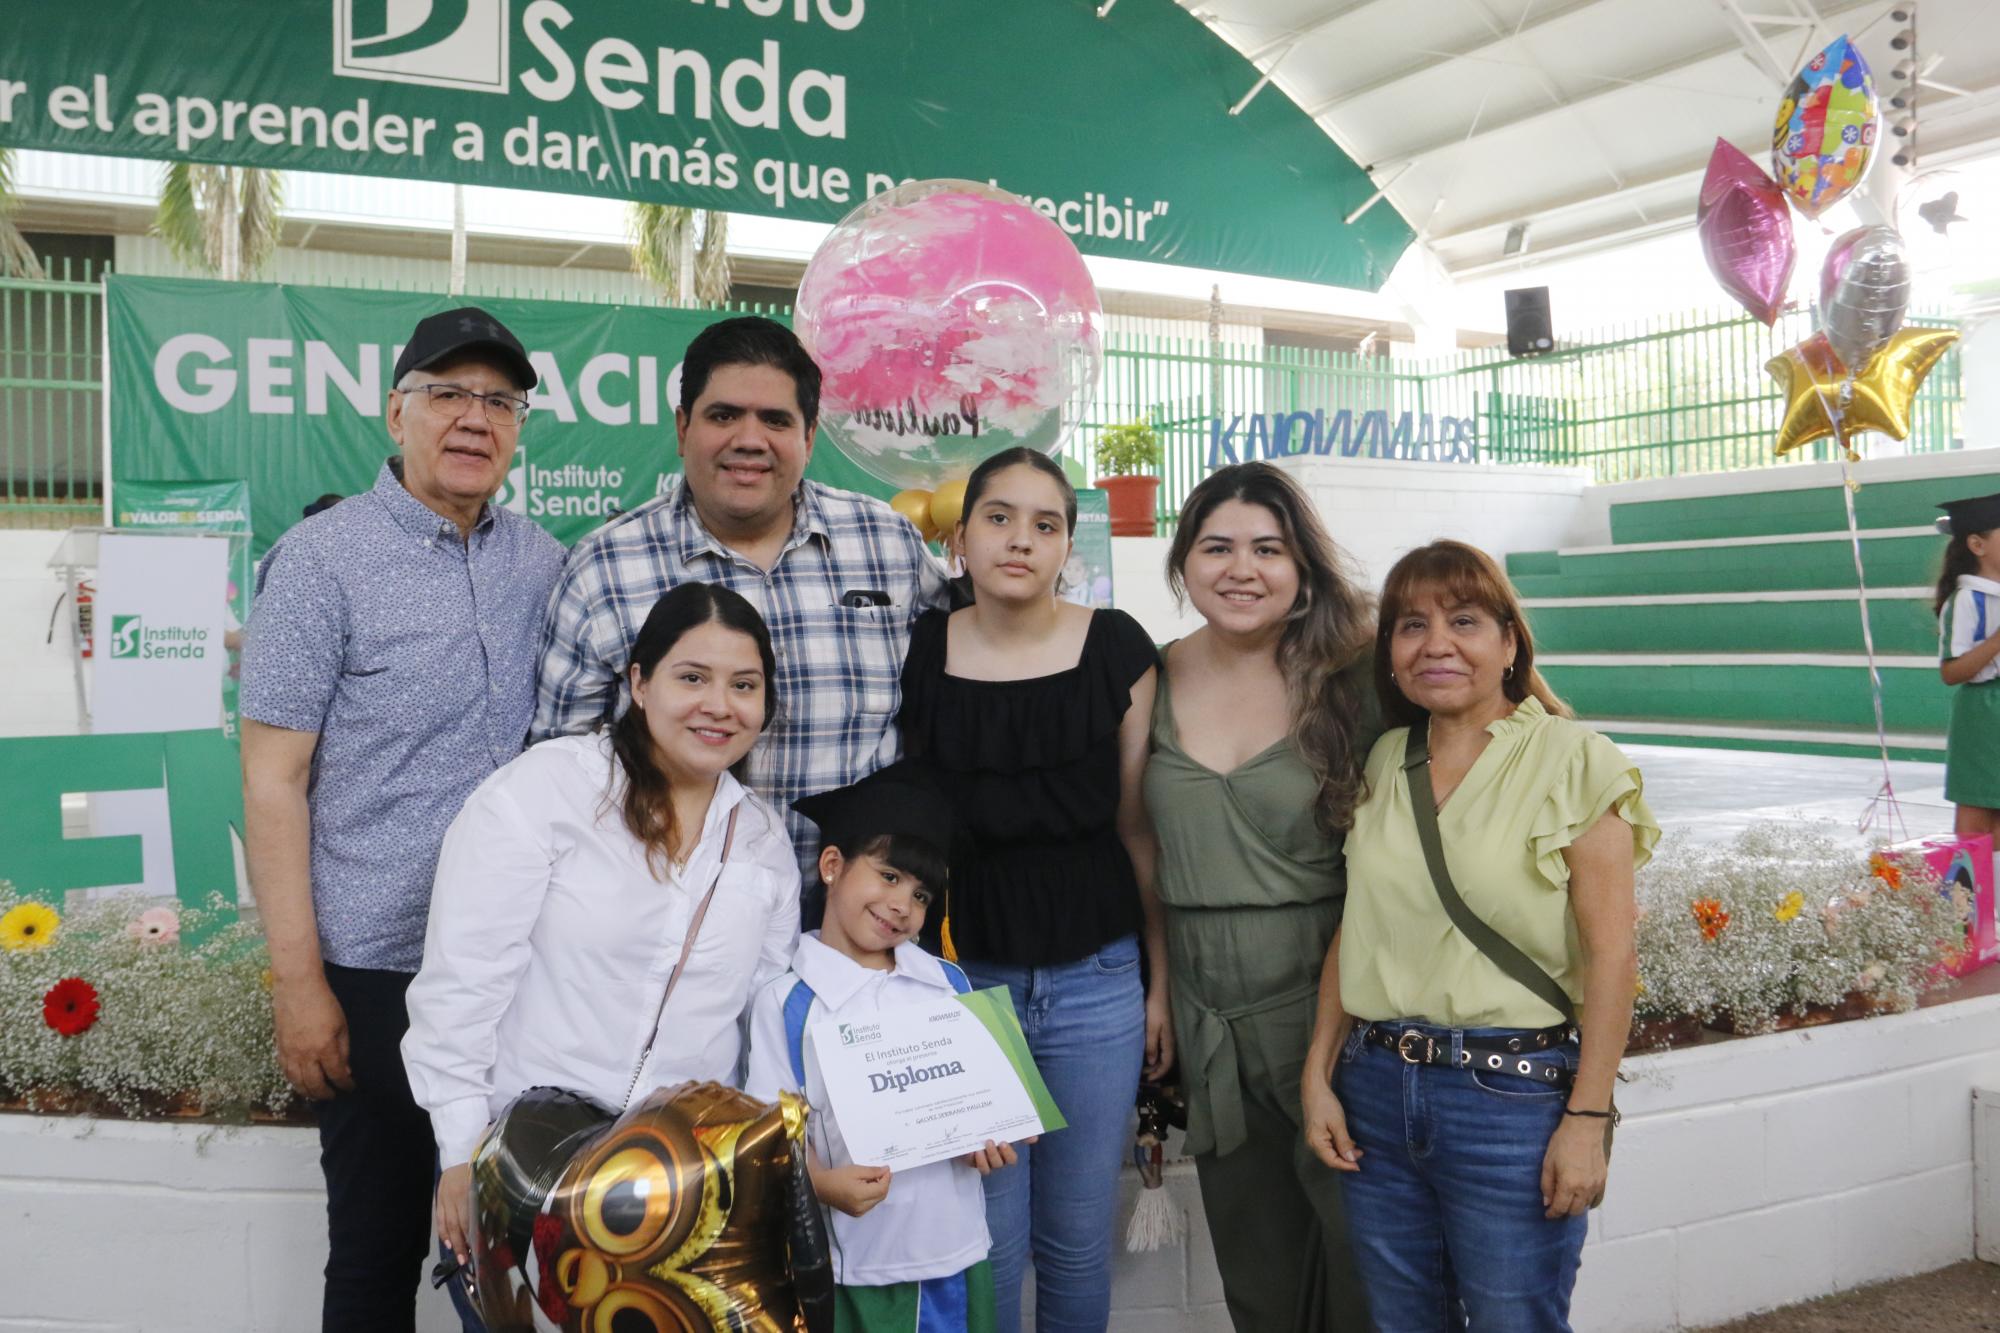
[1146,462,1380,1333]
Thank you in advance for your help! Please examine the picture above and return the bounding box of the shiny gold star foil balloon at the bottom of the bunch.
[1764,326,1958,460]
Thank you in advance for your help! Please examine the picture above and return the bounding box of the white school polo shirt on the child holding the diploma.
[744,931,992,1287]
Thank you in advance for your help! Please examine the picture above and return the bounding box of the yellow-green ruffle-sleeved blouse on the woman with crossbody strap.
[1340,699,1660,1027]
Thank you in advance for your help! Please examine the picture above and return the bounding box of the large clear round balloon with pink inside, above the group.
[794,180,1104,488]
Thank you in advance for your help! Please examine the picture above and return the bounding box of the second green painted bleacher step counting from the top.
[1514,528,1944,596]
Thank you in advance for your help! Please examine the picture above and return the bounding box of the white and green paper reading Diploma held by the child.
[812,987,1064,1171]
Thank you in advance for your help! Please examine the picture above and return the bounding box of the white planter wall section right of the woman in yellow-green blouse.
[1572,980,2000,1333]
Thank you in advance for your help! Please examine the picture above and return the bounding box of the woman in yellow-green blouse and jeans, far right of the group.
[1300,542,1658,1333]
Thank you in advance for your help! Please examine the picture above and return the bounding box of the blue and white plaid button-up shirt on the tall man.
[532,480,946,867]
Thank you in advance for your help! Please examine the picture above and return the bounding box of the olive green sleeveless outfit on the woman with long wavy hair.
[1146,662,1380,1333]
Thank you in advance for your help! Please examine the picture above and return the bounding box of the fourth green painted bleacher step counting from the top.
[1536,652,1950,733]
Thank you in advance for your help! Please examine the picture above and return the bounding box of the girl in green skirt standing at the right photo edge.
[1932,494,2000,841]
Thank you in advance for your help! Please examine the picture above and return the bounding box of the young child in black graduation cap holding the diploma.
[744,765,1016,1333]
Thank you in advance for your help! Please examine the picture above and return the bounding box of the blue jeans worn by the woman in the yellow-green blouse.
[1334,1021,1588,1333]
